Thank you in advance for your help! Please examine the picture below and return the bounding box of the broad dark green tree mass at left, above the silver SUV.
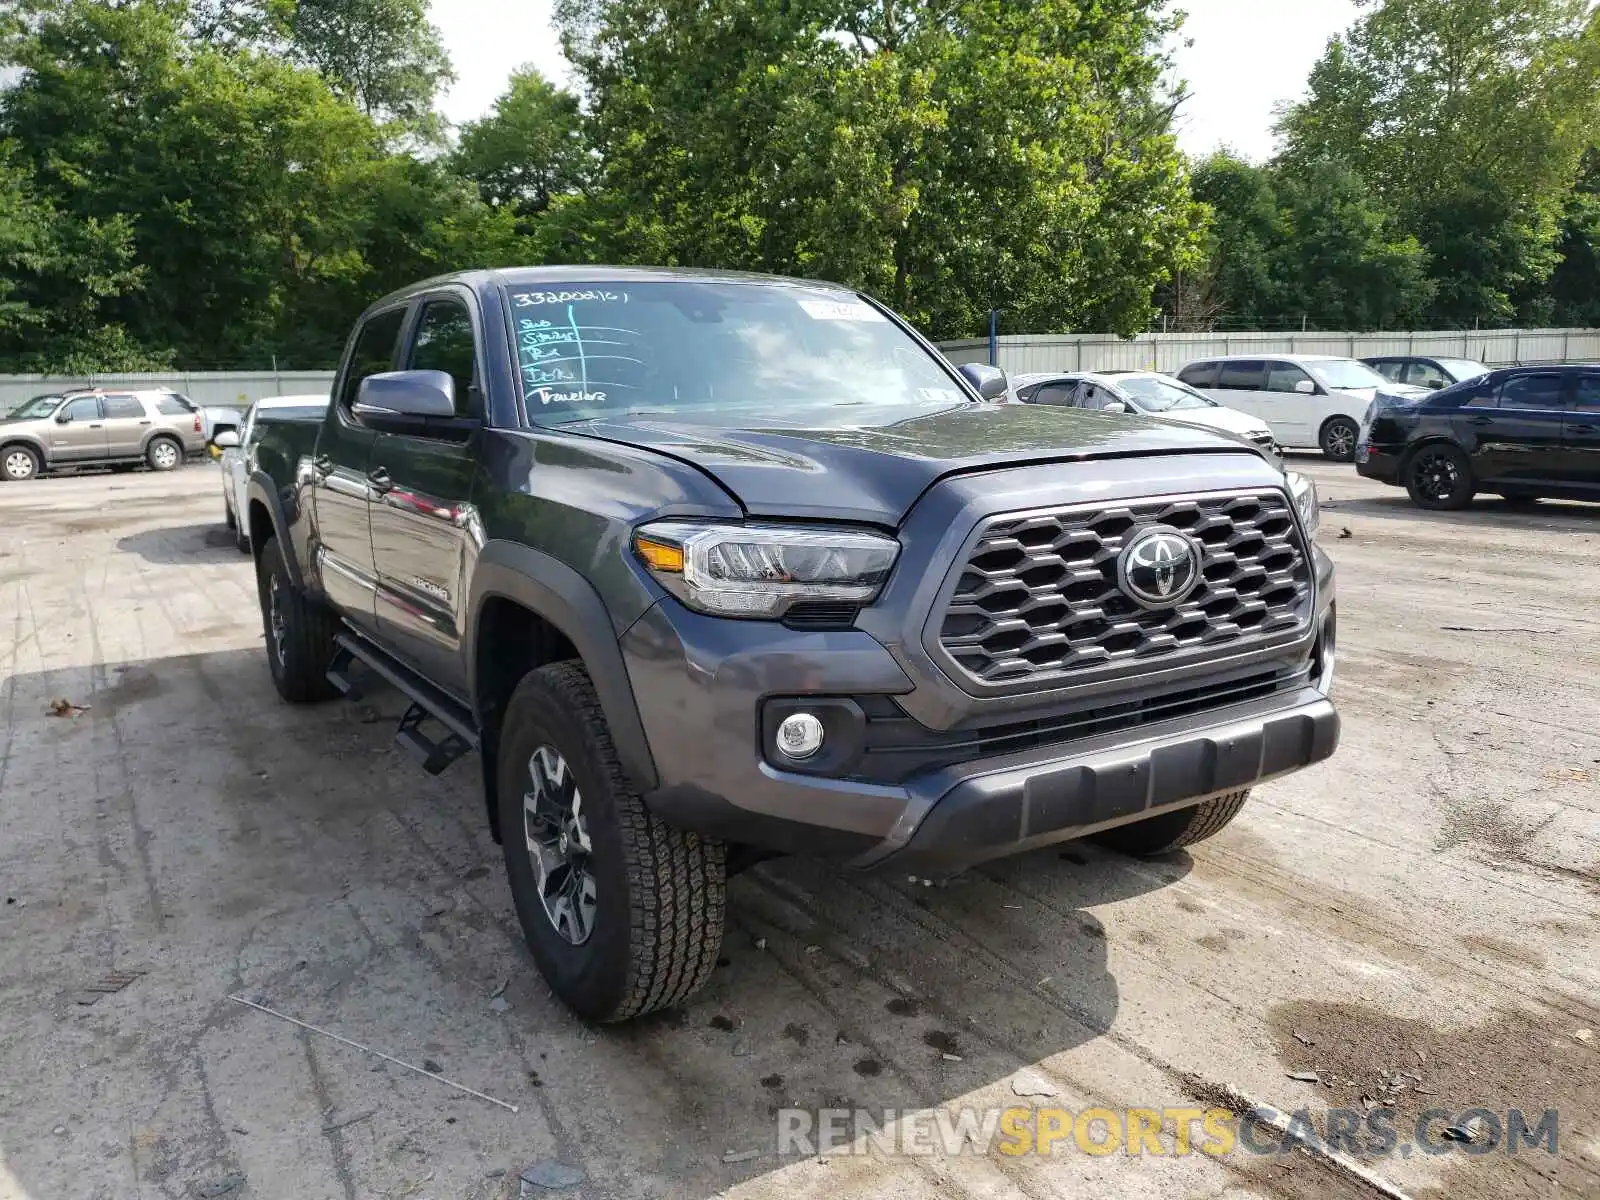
[0,0,518,366]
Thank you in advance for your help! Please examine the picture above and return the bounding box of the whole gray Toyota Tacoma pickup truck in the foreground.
[245,267,1339,1021]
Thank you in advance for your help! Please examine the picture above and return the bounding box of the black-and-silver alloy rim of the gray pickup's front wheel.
[522,746,597,946]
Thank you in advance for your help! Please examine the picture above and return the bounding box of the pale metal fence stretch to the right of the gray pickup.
[939,330,1600,374]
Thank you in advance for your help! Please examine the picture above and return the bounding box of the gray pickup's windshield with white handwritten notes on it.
[510,280,968,424]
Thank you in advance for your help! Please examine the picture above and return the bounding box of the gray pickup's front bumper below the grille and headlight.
[622,592,1339,875]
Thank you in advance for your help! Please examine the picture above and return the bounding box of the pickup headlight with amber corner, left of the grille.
[634,520,899,621]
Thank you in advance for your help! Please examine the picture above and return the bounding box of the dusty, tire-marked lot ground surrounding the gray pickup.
[0,459,1600,1200]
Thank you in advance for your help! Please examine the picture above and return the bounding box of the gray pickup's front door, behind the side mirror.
[371,291,482,698]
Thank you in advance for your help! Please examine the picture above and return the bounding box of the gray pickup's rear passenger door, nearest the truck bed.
[312,306,406,629]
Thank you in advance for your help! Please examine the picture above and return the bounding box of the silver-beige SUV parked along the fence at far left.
[0,389,206,480]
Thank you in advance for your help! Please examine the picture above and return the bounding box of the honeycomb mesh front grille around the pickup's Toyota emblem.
[939,490,1312,686]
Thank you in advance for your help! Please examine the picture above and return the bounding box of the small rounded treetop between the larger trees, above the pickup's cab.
[454,67,590,216]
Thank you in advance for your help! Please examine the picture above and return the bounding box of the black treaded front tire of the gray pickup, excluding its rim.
[498,661,726,1022]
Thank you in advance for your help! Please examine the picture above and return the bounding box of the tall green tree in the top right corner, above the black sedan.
[1280,0,1600,325]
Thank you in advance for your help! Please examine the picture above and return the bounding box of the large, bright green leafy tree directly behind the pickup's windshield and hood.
[560,0,1197,336]
